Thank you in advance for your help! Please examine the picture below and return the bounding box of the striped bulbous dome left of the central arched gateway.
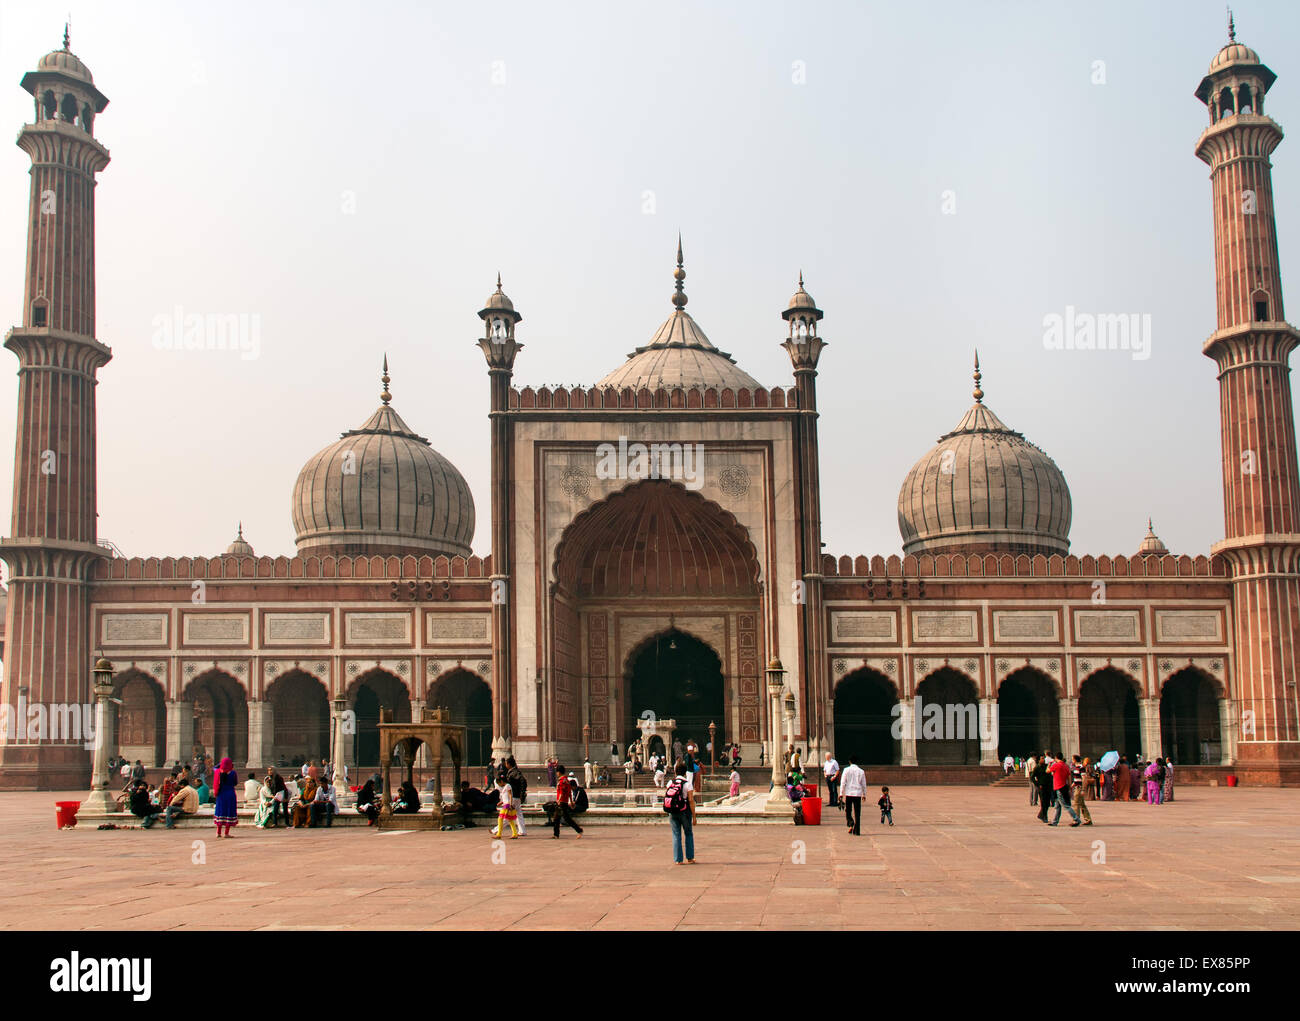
[293,358,475,557]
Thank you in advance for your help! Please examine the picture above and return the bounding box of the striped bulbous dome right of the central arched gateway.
[898,355,1070,555]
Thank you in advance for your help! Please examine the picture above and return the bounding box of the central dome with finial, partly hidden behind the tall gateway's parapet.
[597,238,762,390]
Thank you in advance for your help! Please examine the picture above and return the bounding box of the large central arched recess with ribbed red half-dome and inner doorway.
[542,481,766,757]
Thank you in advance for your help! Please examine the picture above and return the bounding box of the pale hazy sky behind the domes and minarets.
[0,0,1300,555]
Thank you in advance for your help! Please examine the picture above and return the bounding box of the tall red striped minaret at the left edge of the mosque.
[0,31,112,789]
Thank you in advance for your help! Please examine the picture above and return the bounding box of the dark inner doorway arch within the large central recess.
[623,628,727,753]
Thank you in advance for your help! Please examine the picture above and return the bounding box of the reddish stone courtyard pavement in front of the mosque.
[0,787,1300,930]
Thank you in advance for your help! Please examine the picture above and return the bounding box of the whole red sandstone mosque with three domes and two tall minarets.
[0,25,1300,789]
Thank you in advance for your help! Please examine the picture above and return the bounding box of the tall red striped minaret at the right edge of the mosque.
[1196,18,1300,780]
